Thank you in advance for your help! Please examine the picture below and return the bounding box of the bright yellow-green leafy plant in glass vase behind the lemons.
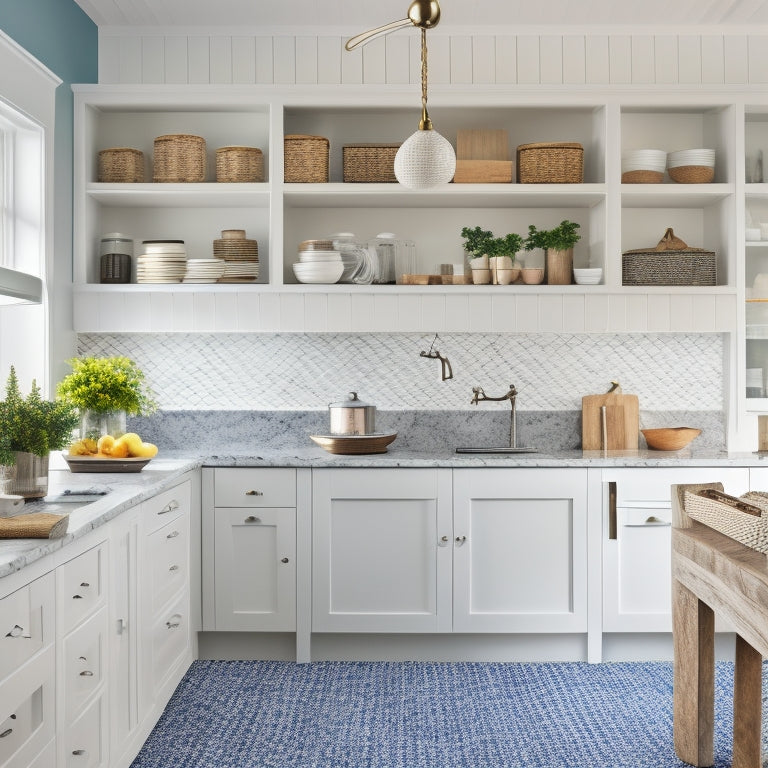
[56,357,157,439]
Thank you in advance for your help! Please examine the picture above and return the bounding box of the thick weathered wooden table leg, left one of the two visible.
[672,579,715,768]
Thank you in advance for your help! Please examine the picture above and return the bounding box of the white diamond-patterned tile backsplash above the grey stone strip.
[78,334,724,416]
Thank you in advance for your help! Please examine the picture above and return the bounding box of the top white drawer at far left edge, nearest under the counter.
[0,573,54,681]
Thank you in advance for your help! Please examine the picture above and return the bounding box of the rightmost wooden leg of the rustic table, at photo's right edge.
[733,635,763,768]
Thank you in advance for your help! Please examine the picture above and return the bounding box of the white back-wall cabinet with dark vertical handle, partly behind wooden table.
[602,467,750,632]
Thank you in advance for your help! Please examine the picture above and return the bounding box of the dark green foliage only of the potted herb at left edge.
[0,366,78,466]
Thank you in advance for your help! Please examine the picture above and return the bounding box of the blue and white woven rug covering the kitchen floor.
[133,661,760,768]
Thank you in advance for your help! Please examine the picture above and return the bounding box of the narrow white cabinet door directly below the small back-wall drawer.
[214,507,296,632]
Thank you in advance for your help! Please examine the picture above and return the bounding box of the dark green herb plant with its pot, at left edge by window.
[0,366,78,498]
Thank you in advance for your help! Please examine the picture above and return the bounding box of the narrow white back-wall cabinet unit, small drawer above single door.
[203,468,297,632]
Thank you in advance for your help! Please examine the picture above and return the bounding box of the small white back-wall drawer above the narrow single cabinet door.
[214,468,296,507]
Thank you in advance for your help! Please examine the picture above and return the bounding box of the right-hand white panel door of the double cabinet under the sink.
[452,469,587,633]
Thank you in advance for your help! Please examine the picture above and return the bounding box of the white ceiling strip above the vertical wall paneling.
[70,0,768,30]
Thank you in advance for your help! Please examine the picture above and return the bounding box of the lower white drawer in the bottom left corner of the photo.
[0,646,55,768]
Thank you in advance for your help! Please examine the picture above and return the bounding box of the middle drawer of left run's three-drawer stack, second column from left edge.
[63,607,107,724]
